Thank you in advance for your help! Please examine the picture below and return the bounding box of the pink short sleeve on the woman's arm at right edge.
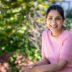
[60,36,72,61]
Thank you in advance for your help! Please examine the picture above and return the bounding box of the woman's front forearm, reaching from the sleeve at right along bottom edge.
[32,60,68,72]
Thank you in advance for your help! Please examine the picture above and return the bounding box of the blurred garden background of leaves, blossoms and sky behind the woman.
[0,0,72,72]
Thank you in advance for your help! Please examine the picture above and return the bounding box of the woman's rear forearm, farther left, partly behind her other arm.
[21,58,50,72]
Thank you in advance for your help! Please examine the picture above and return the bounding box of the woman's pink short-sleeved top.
[42,30,72,72]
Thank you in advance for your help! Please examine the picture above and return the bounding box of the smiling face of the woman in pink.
[46,10,64,32]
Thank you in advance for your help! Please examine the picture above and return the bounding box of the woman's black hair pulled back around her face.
[46,5,65,19]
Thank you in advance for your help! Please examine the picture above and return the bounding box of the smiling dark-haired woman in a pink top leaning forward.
[22,5,72,72]
